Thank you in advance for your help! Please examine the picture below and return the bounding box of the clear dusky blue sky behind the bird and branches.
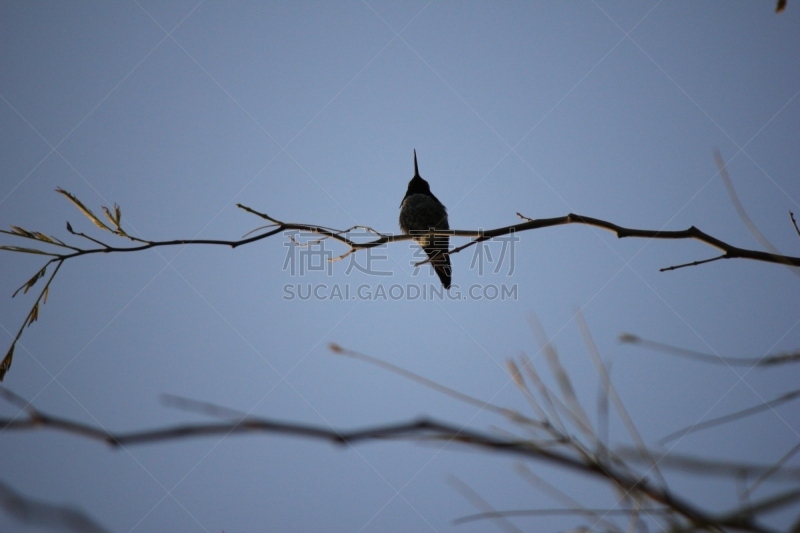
[0,0,800,532]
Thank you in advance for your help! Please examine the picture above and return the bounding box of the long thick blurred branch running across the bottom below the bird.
[0,389,800,532]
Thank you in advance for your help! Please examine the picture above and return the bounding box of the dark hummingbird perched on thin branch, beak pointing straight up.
[400,150,452,289]
